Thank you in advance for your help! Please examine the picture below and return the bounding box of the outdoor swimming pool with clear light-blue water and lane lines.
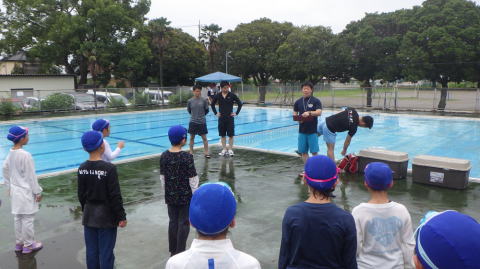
[0,107,480,181]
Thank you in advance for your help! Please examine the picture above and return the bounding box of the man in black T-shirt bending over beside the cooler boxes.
[318,107,373,161]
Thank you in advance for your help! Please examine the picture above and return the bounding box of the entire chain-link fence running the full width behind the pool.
[0,84,480,115]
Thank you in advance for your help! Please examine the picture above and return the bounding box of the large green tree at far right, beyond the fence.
[399,0,480,110]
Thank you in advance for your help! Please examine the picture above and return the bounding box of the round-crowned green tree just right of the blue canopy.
[219,18,295,102]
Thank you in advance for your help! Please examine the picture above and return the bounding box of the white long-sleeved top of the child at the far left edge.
[3,149,43,214]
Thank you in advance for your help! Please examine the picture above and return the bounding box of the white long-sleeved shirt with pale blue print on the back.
[352,202,415,269]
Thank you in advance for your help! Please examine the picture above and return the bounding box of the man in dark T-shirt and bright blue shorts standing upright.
[293,82,322,174]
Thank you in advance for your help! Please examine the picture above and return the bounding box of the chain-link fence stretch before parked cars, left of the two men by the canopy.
[0,86,192,115]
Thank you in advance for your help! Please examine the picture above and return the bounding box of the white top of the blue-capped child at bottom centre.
[165,239,261,269]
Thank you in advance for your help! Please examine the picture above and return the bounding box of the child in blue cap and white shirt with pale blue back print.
[352,162,415,268]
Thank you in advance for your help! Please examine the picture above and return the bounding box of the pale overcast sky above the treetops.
[148,0,480,37]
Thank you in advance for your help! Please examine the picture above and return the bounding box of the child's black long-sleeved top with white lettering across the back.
[77,161,126,228]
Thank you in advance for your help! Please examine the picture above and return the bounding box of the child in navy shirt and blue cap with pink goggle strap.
[278,155,357,269]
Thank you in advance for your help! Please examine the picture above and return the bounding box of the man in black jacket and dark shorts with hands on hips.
[211,81,242,156]
